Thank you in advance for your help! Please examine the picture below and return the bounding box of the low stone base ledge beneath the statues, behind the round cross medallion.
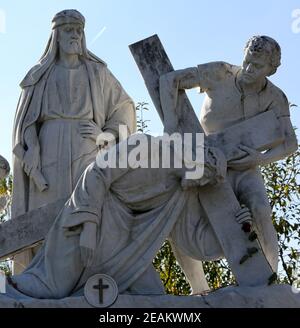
[0,285,300,309]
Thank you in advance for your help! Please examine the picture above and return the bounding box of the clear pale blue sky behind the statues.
[0,0,300,164]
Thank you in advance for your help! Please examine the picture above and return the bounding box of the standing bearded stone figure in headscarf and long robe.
[11,10,136,273]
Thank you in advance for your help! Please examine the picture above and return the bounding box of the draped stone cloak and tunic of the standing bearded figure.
[12,59,136,217]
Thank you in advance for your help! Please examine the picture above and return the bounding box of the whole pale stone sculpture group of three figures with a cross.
[0,10,298,304]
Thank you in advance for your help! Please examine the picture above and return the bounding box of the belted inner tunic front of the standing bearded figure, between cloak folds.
[28,65,98,210]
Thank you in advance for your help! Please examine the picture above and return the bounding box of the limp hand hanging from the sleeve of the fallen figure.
[79,222,97,267]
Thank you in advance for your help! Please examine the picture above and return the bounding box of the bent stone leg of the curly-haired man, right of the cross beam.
[236,169,278,272]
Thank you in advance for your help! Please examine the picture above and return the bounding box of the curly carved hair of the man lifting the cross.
[244,35,281,75]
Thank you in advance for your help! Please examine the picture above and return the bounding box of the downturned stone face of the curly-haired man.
[242,51,272,84]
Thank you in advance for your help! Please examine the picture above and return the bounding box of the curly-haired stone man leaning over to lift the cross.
[155,35,298,282]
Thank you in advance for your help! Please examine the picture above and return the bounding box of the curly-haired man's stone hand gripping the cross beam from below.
[227,145,263,171]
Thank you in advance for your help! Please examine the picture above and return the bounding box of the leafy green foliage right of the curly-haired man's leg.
[263,149,300,284]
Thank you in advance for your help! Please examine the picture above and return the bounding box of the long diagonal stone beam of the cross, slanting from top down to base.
[130,35,281,286]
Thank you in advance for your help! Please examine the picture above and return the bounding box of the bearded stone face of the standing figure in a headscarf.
[58,24,83,55]
